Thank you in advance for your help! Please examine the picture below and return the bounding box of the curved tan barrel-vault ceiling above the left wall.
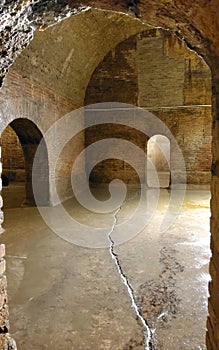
[13,9,148,105]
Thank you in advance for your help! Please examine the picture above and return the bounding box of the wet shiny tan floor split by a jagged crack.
[1,186,210,350]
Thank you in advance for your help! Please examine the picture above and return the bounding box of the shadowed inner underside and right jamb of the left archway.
[1,118,49,205]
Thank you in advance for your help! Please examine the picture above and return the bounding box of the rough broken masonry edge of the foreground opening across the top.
[0,0,219,88]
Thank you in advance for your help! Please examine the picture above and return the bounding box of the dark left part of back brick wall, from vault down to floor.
[85,36,142,183]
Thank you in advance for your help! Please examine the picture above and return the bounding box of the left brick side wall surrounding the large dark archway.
[0,69,84,205]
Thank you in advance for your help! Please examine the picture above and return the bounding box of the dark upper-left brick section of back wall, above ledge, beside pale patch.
[85,36,138,105]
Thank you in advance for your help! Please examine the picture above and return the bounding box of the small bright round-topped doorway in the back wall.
[147,135,171,188]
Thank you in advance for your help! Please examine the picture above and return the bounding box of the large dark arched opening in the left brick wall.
[2,118,49,206]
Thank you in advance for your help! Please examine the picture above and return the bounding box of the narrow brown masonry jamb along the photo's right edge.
[206,58,219,350]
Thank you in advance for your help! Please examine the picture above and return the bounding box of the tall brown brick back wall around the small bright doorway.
[85,30,211,184]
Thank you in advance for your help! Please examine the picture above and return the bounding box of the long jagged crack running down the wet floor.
[108,206,153,350]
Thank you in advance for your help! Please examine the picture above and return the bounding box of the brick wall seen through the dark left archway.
[1,126,25,182]
